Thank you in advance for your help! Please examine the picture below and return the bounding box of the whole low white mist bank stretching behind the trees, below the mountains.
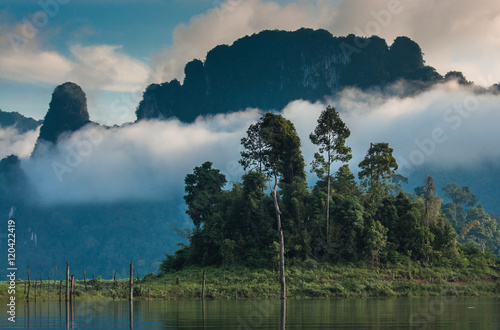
[14,83,500,203]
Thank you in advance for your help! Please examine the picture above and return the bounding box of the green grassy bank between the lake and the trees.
[0,260,500,301]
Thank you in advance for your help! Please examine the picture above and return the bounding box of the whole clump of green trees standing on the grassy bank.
[161,108,500,274]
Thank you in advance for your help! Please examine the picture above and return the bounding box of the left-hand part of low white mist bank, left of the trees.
[23,110,258,203]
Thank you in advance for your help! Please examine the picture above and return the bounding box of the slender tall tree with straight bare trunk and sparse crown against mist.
[309,106,352,245]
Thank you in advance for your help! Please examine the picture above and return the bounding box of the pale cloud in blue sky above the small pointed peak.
[0,23,149,92]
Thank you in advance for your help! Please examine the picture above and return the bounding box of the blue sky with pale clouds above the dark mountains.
[0,0,500,124]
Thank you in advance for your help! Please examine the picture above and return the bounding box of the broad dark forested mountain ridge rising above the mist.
[136,28,444,122]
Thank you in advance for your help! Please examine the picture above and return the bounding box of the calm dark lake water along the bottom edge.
[0,297,500,329]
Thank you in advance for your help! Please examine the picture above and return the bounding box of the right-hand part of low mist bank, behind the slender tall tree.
[283,83,500,176]
